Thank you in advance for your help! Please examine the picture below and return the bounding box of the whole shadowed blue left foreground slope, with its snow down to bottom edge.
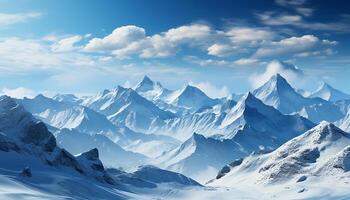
[0,96,201,199]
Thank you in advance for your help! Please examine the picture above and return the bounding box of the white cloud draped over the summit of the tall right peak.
[249,60,304,88]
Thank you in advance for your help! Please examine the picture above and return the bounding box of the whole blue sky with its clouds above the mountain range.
[0,0,350,96]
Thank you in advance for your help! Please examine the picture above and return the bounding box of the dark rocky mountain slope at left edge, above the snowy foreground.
[0,96,114,184]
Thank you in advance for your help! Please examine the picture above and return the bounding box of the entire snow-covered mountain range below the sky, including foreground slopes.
[0,63,350,199]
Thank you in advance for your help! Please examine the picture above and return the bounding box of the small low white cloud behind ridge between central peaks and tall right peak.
[189,81,230,98]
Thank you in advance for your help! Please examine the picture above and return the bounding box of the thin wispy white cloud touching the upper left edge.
[0,12,41,27]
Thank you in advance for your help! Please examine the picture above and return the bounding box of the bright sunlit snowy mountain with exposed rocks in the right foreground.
[211,122,350,186]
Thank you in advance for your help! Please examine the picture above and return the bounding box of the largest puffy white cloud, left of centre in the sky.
[85,24,212,59]
